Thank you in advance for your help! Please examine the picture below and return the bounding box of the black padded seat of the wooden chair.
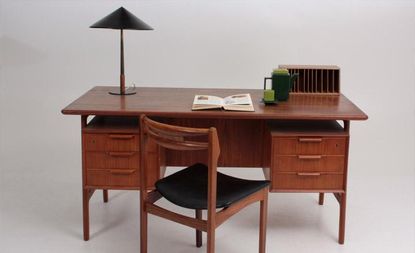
[155,163,269,209]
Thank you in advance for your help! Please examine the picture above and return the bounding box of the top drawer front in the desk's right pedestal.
[272,137,346,156]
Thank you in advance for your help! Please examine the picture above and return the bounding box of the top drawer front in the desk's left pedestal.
[83,134,140,151]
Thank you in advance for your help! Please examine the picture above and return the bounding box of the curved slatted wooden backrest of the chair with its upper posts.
[140,115,220,194]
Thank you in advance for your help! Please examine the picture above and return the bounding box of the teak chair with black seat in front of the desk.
[140,115,269,253]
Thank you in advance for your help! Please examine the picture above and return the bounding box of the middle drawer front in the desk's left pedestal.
[85,151,140,169]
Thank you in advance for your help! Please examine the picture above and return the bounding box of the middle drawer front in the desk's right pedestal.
[272,155,344,173]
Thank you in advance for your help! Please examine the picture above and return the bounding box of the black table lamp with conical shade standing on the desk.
[90,7,153,95]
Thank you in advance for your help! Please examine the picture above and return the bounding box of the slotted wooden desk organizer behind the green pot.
[279,65,340,95]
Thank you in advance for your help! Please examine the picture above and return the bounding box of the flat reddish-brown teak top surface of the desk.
[62,86,368,120]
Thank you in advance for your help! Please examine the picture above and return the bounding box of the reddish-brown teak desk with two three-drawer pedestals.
[62,87,368,244]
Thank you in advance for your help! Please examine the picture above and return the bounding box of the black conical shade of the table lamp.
[90,7,153,30]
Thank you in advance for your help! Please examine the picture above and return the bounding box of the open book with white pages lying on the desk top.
[192,94,255,112]
